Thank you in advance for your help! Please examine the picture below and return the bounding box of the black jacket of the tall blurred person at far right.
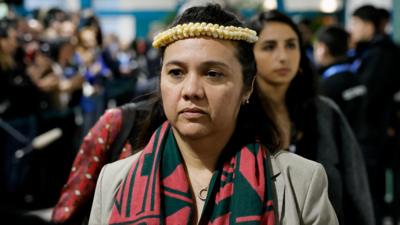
[355,35,400,161]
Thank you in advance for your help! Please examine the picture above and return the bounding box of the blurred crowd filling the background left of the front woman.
[0,8,159,217]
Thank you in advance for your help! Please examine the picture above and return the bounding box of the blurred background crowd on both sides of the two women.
[0,5,400,225]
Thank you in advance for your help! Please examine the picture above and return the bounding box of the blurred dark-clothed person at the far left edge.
[0,19,44,221]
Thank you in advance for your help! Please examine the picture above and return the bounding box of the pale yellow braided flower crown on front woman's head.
[153,22,258,48]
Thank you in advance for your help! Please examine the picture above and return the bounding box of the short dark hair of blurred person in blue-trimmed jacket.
[316,26,350,57]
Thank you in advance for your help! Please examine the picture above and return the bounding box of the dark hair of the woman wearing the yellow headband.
[134,4,276,150]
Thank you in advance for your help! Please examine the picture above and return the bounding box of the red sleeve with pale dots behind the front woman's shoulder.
[52,109,132,223]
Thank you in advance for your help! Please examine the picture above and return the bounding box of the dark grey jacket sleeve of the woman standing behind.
[306,97,375,225]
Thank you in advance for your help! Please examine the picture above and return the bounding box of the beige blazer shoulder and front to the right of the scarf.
[271,150,338,225]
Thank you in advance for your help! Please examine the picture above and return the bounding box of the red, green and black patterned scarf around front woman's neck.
[109,122,275,225]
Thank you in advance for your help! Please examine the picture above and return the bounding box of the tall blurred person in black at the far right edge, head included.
[350,5,400,224]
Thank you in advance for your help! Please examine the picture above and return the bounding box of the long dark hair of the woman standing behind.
[249,10,317,157]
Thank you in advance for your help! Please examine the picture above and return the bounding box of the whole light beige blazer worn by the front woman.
[89,151,339,225]
